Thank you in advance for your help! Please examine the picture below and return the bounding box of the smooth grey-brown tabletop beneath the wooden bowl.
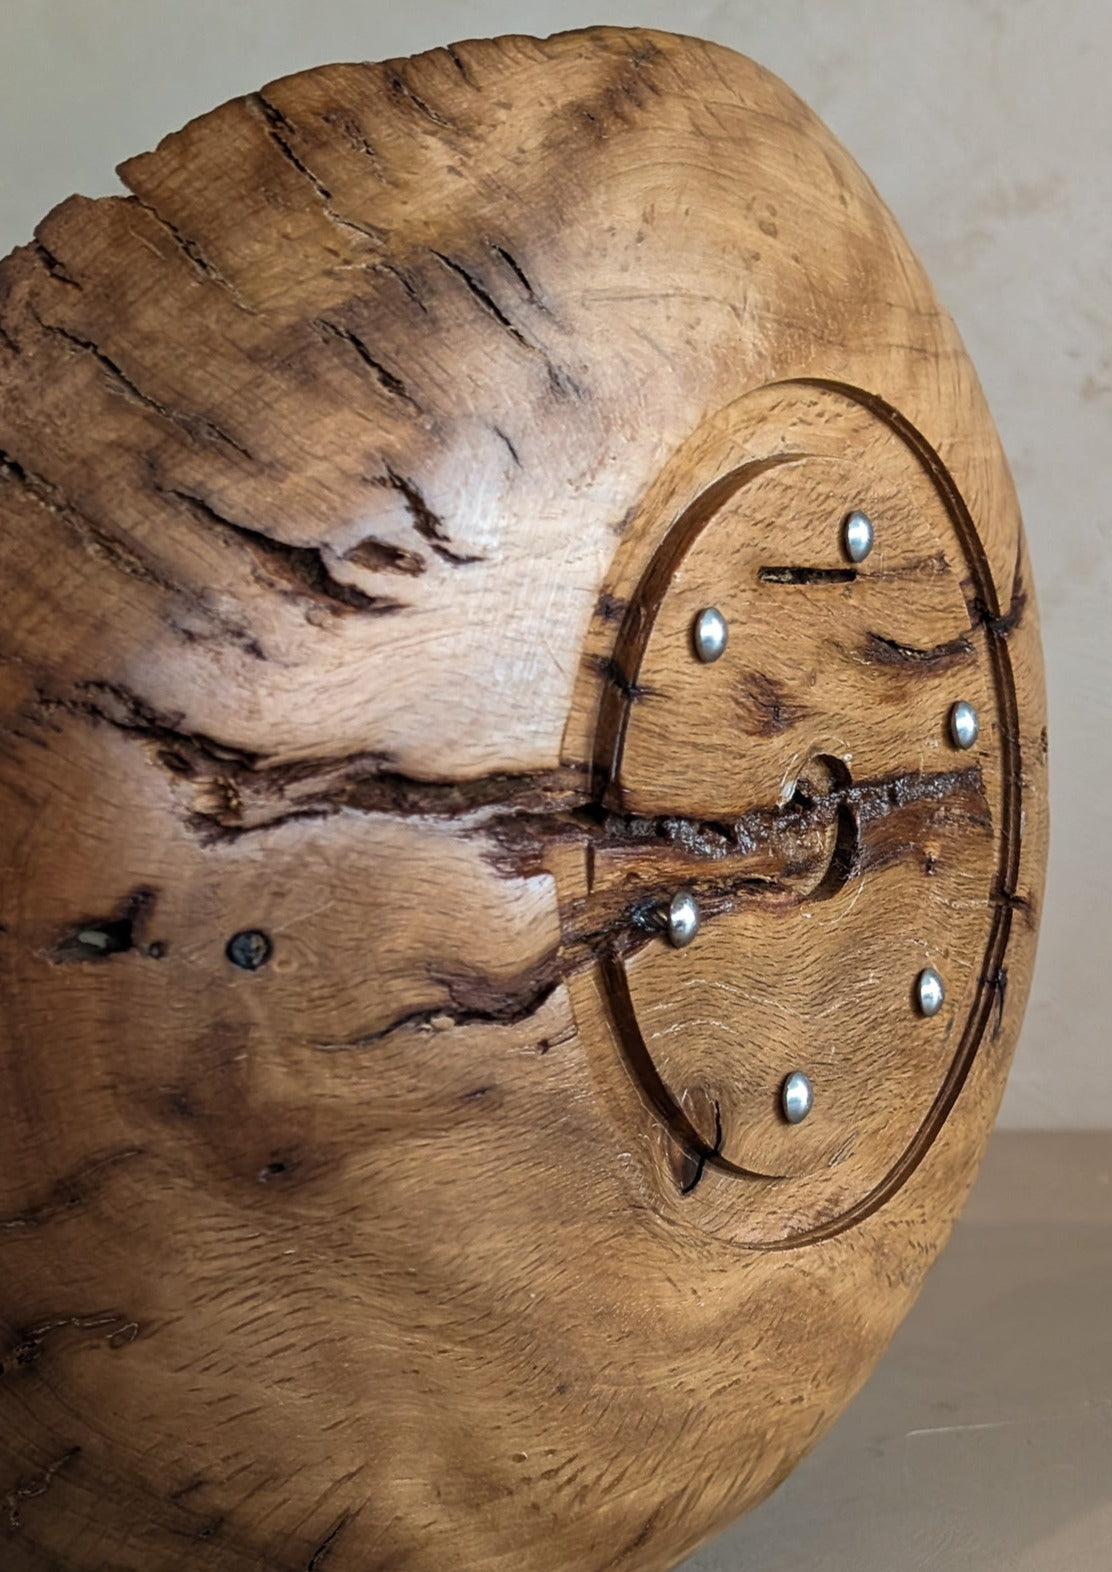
[681,1130,1112,1572]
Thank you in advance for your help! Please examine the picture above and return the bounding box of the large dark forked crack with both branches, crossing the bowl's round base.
[30,666,992,1052]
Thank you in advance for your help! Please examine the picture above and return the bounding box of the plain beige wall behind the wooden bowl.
[0,0,1112,1127]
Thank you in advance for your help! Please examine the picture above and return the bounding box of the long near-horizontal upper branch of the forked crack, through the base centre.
[38,682,994,886]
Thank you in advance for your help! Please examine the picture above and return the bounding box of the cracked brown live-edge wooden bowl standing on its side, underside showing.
[0,28,1046,1572]
